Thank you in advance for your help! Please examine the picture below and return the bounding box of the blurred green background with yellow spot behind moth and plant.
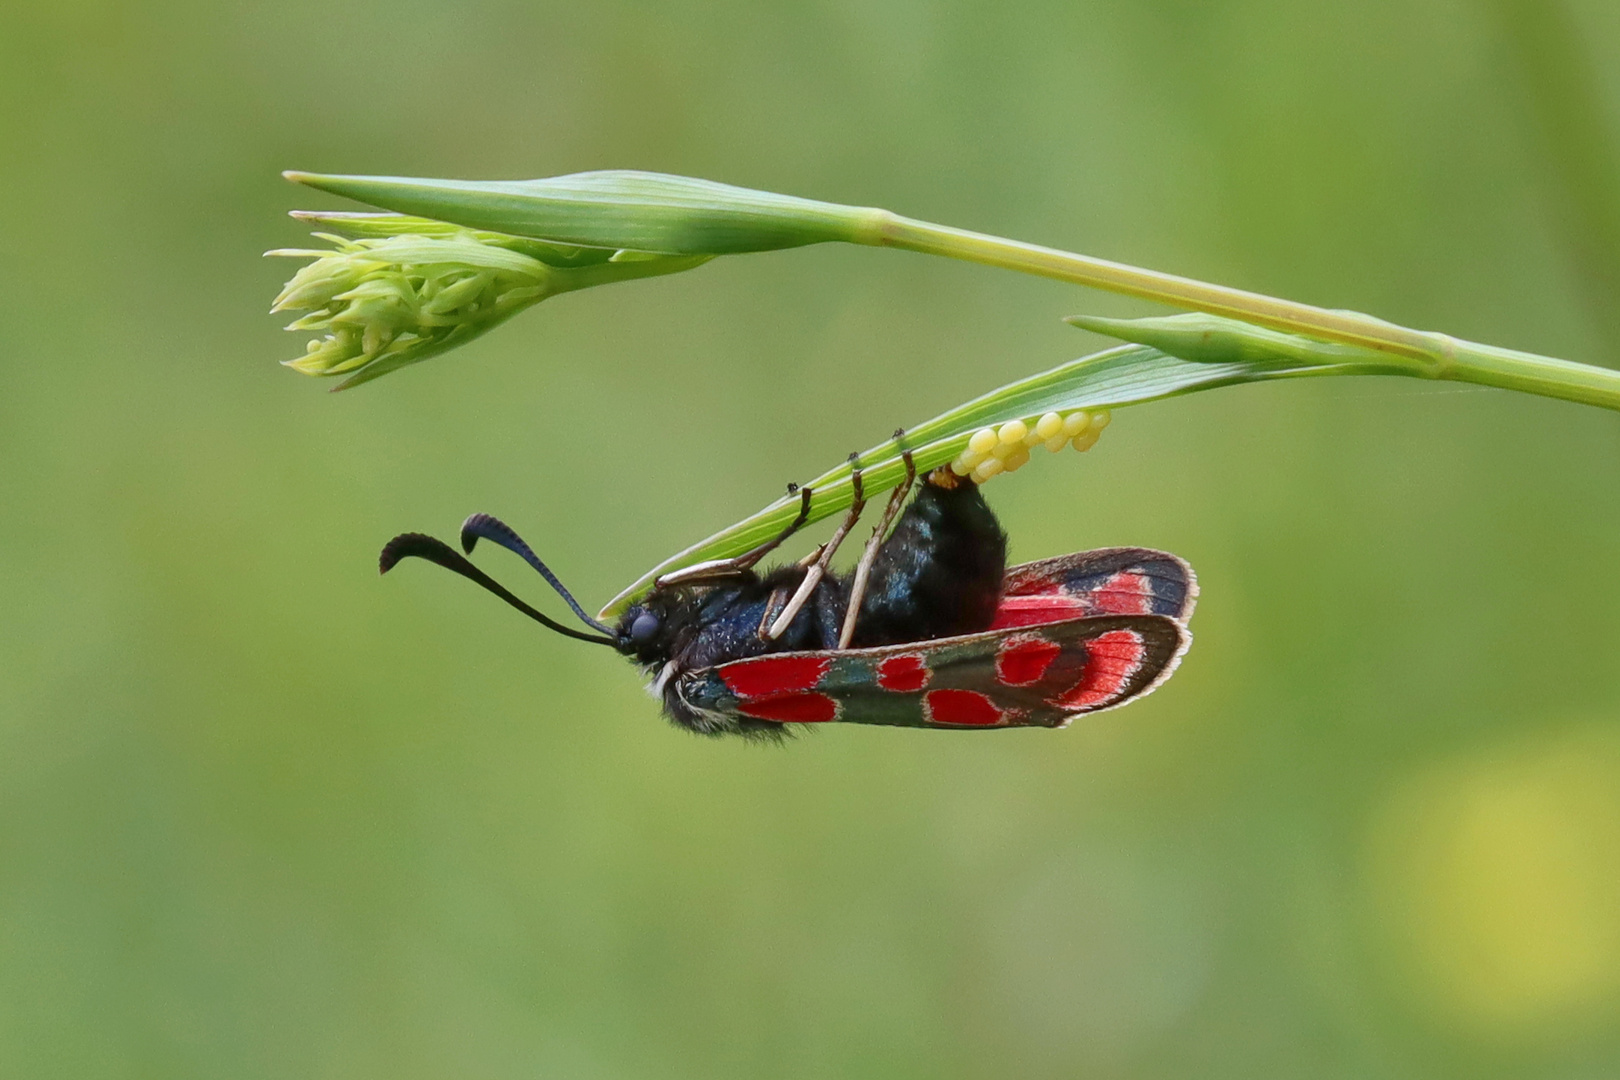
[0,0,1620,1080]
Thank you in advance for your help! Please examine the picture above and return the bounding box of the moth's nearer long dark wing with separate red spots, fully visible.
[677,615,1191,729]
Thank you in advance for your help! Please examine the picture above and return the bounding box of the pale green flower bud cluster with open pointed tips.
[267,214,706,390]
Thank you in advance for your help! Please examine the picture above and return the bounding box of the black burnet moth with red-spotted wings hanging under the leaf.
[379,432,1197,738]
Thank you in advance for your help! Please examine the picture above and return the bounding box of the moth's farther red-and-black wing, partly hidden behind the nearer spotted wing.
[991,547,1199,630]
